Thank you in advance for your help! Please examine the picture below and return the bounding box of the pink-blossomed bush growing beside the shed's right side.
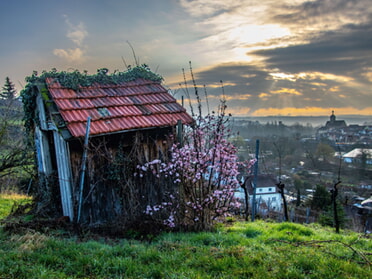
[138,101,254,231]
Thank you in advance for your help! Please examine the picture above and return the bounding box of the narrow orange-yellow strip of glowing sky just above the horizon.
[251,107,372,116]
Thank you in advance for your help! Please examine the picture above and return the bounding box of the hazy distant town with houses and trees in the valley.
[232,111,372,232]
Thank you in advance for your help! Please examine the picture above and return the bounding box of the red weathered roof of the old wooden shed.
[46,78,193,137]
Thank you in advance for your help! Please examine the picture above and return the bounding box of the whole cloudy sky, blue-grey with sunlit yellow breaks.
[0,0,372,116]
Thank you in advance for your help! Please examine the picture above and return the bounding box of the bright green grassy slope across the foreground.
[0,194,372,279]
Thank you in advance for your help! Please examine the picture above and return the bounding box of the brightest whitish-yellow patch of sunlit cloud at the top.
[180,0,291,63]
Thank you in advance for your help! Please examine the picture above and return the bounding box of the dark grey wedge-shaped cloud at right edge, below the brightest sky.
[250,22,372,75]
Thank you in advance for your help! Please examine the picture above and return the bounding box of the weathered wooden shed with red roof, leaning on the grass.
[28,68,193,228]
